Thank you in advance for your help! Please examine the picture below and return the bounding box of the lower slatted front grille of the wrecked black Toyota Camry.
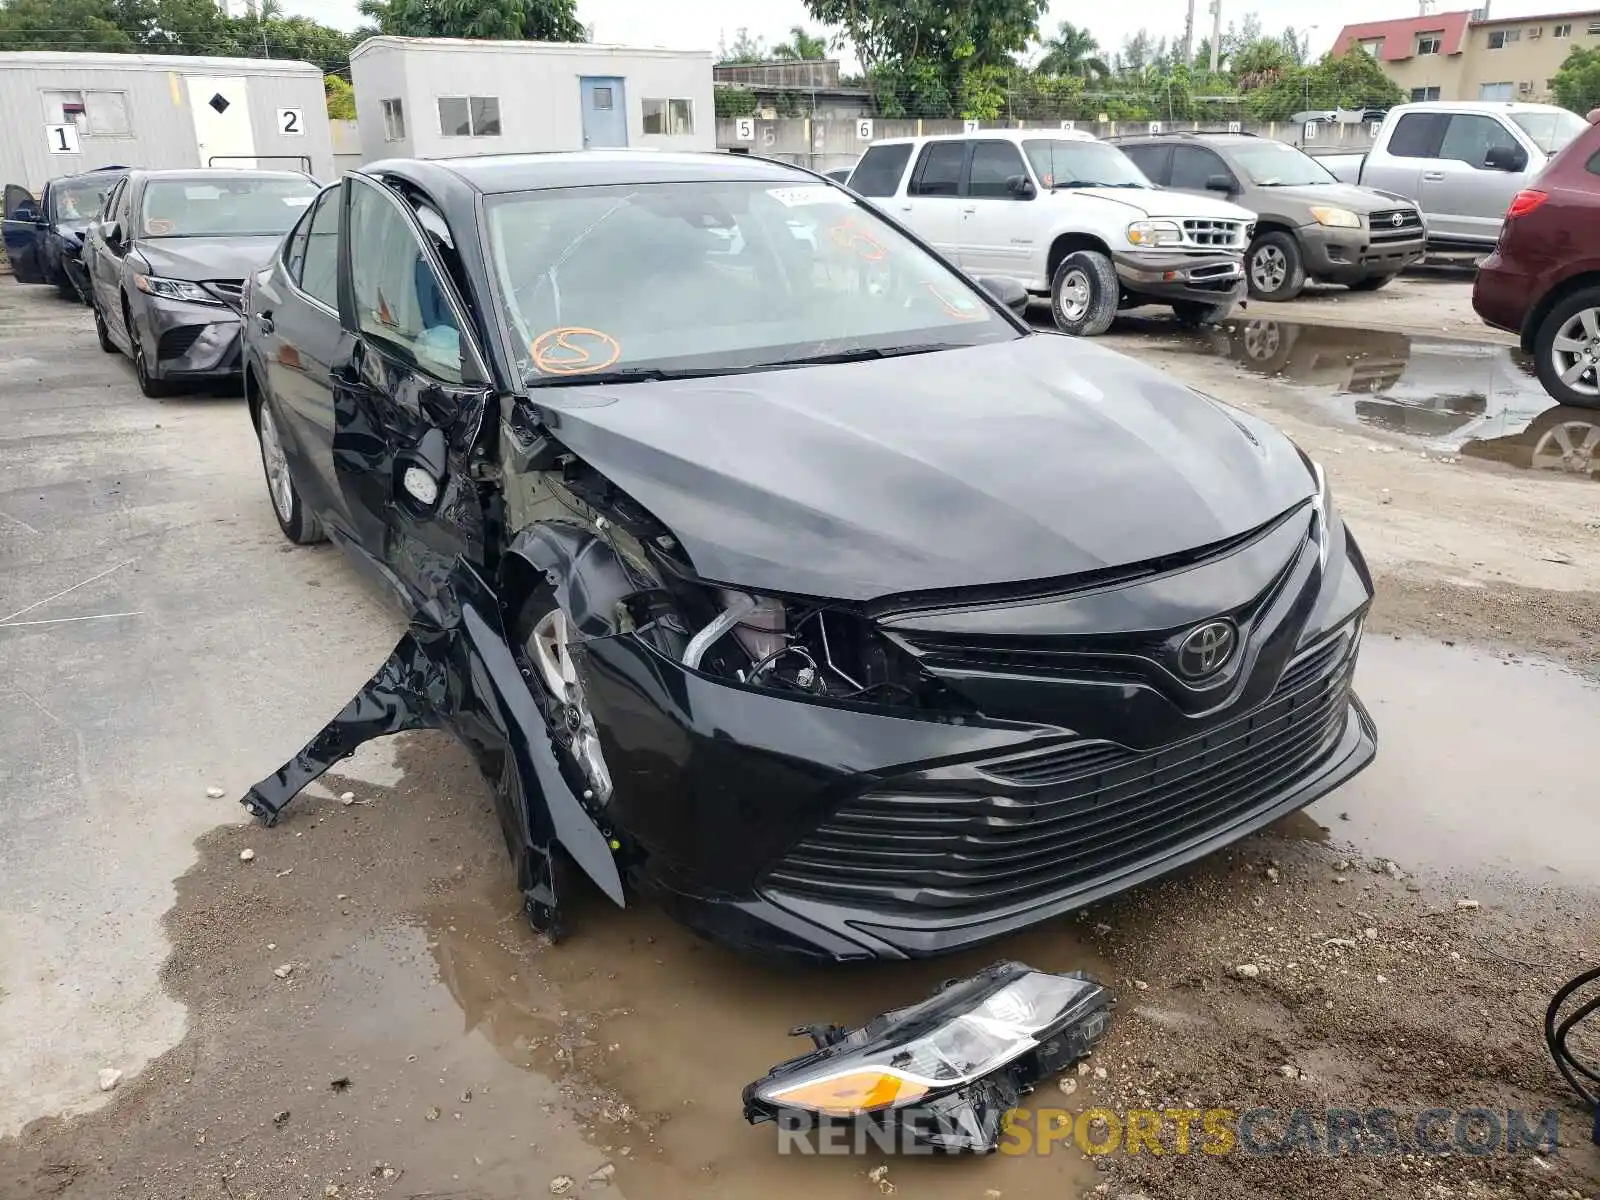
[766,635,1354,914]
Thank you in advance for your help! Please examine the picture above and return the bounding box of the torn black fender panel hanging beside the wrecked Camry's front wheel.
[242,563,624,925]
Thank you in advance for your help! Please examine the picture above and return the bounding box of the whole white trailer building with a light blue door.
[350,37,717,162]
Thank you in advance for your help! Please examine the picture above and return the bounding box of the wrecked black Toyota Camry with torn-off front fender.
[245,152,1376,960]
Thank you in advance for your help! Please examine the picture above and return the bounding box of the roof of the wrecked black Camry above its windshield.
[360,150,818,195]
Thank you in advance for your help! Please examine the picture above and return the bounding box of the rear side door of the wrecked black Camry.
[257,184,352,526]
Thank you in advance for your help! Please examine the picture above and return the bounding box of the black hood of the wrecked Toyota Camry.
[534,334,1314,600]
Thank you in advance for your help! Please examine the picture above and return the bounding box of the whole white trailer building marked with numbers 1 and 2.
[0,51,334,192]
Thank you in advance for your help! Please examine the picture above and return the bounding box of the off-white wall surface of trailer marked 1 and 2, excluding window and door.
[0,53,333,192]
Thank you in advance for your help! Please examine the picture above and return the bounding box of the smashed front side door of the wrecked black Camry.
[330,173,498,613]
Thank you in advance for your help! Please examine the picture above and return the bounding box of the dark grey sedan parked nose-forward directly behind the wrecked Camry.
[83,170,320,397]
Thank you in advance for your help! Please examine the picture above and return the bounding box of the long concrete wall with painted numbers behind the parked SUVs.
[717,117,1373,171]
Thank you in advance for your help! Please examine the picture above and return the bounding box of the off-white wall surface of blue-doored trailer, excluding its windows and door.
[360,37,715,160]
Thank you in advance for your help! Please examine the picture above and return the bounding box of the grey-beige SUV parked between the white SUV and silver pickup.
[1117,133,1427,301]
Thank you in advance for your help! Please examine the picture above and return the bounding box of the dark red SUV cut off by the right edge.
[1472,109,1600,408]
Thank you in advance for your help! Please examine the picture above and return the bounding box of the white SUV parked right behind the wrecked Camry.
[850,130,1256,334]
